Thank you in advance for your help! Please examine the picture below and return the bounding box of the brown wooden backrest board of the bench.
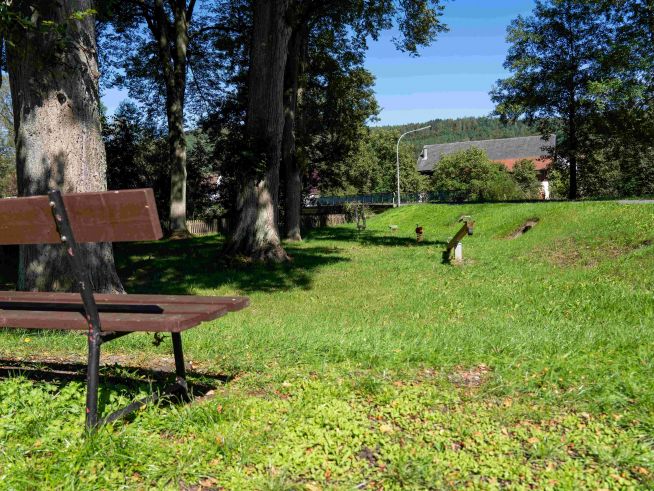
[0,189,163,244]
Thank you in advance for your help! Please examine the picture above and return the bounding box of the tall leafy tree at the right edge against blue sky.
[491,0,654,198]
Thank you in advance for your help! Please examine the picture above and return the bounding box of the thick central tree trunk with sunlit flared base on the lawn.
[226,0,291,261]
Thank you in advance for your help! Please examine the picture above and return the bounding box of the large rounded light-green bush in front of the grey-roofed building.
[432,148,524,201]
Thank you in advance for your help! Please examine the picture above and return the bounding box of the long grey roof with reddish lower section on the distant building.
[417,135,556,174]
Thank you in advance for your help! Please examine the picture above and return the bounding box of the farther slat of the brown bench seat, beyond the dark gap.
[0,291,250,312]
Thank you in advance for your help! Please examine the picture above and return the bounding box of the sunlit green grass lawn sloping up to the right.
[0,202,654,490]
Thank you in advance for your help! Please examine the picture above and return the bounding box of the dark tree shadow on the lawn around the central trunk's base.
[114,236,348,294]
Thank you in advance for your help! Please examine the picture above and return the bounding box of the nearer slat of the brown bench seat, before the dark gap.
[0,310,227,332]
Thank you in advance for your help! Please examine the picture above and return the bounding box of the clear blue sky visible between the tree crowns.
[102,0,534,125]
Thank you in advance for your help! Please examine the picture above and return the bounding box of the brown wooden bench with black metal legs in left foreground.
[0,189,249,429]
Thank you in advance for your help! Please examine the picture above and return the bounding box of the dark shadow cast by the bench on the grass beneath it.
[0,358,233,420]
